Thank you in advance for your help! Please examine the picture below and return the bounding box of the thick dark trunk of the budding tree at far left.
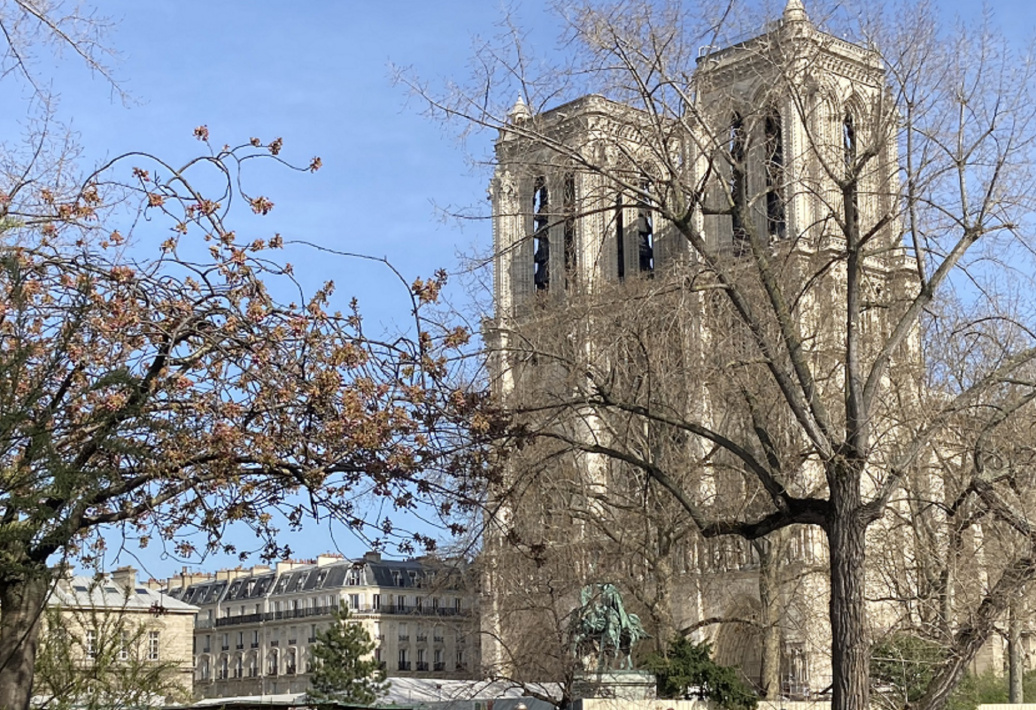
[0,569,51,710]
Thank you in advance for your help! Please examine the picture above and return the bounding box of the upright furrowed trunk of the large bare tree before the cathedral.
[827,476,870,710]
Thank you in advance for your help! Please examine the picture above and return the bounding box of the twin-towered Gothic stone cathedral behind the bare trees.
[482,0,990,698]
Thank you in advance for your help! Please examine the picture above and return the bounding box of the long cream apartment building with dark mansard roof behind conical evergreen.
[168,552,479,698]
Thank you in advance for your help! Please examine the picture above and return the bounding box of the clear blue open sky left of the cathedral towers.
[12,0,1036,576]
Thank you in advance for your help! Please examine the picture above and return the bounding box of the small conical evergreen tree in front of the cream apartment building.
[309,604,389,705]
